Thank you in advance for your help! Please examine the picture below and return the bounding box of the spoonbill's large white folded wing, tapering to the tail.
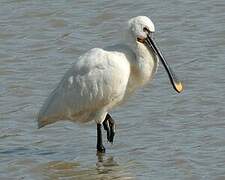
[38,48,130,127]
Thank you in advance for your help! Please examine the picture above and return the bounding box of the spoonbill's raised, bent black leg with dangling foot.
[103,114,115,143]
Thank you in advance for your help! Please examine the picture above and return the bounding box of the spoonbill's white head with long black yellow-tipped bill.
[128,16,183,93]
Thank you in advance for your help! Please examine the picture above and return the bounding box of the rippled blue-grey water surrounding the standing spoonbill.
[0,0,225,180]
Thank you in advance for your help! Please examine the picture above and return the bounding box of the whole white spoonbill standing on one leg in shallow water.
[38,16,183,153]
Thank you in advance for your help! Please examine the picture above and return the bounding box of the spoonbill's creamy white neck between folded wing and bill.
[131,44,158,86]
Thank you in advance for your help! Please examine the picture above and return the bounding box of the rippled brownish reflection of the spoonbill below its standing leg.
[33,154,135,180]
